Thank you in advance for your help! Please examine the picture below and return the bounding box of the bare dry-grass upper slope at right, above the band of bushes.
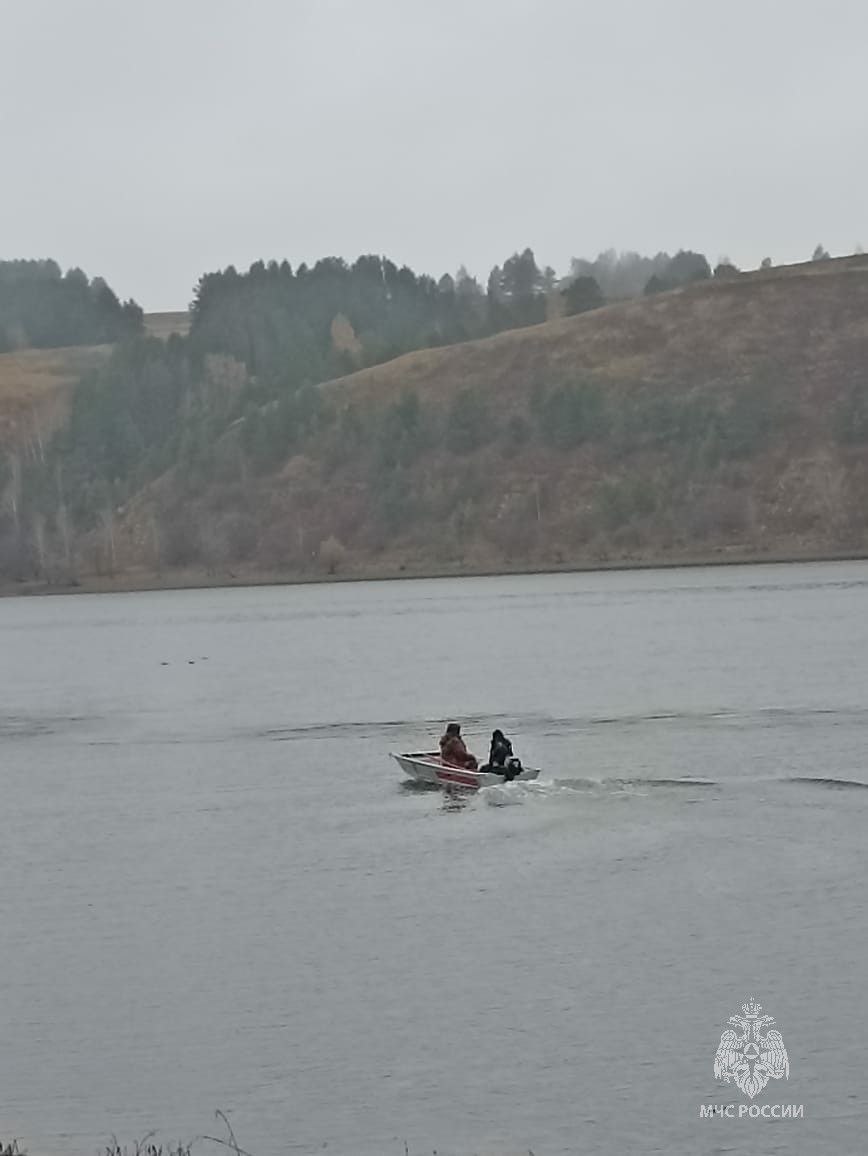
[324,257,868,413]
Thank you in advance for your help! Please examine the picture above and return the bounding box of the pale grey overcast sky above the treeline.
[0,0,868,310]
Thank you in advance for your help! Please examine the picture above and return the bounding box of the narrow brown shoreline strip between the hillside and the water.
[0,549,868,598]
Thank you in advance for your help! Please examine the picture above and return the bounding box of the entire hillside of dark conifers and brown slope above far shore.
[0,243,868,585]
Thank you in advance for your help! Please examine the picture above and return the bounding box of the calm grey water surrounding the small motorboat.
[0,564,868,1156]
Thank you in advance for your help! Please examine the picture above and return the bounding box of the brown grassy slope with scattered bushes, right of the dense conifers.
[110,258,868,580]
